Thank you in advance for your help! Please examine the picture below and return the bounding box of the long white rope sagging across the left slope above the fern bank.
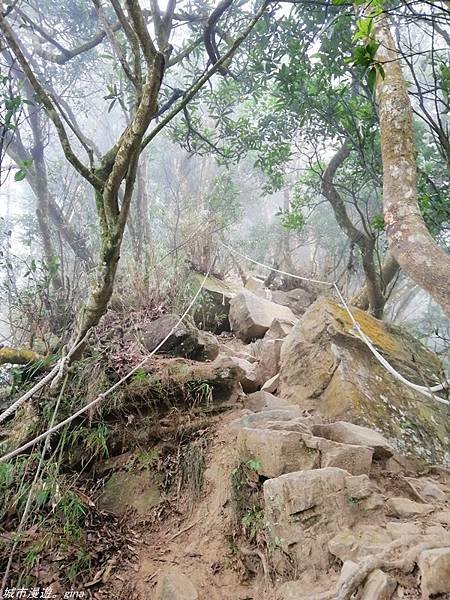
[0,254,217,463]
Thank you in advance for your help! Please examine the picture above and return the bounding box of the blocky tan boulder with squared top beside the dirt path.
[263,467,381,571]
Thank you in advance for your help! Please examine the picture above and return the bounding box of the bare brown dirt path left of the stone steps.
[112,409,274,600]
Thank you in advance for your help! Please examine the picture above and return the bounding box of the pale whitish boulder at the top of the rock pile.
[229,291,296,342]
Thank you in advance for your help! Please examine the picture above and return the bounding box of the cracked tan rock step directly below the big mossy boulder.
[235,408,393,478]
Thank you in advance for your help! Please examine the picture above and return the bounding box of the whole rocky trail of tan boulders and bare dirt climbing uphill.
[92,274,450,600]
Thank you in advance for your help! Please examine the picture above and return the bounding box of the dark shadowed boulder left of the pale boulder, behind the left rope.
[140,314,219,360]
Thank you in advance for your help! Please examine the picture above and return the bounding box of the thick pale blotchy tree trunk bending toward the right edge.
[375,15,450,317]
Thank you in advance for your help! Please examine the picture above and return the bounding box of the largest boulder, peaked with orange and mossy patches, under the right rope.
[278,298,450,464]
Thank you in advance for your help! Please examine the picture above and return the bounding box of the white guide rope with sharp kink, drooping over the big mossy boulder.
[222,243,449,405]
